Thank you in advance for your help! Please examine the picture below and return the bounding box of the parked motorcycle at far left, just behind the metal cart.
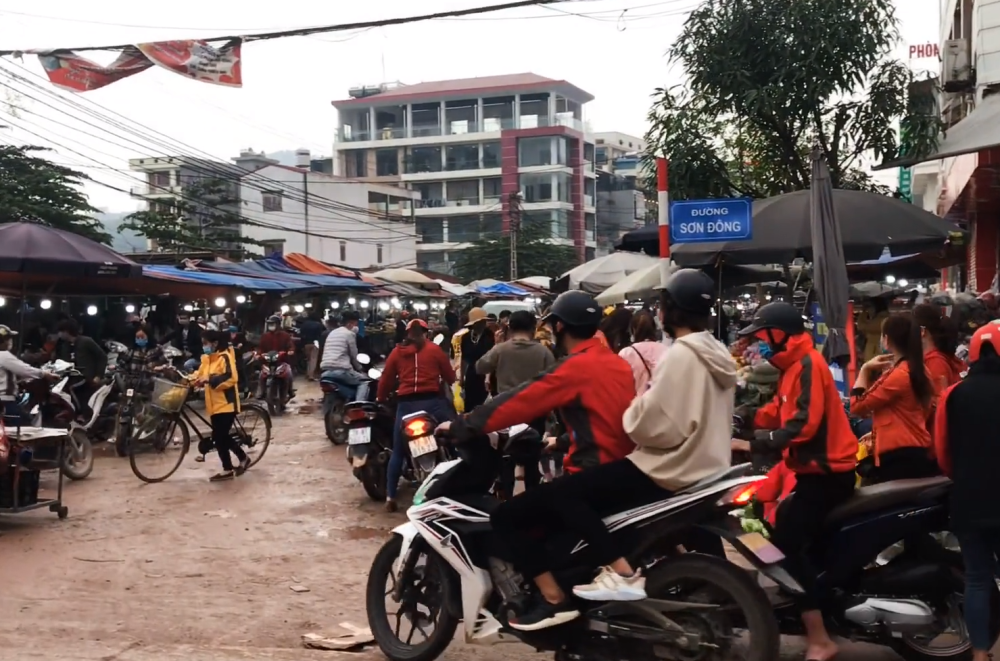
[21,360,96,480]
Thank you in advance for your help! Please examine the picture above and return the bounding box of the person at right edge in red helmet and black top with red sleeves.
[934,321,1000,661]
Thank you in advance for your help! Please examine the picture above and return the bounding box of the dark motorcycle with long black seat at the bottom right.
[760,477,1000,661]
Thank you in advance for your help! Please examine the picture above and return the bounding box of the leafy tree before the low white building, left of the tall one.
[121,179,260,257]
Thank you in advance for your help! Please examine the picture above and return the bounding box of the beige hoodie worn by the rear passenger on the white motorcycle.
[623,332,736,491]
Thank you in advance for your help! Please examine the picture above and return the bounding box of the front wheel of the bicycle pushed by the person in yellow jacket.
[128,412,191,482]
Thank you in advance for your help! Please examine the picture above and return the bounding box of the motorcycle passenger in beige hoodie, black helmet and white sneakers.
[493,269,736,631]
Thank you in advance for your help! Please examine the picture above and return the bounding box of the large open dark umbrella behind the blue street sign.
[619,189,961,266]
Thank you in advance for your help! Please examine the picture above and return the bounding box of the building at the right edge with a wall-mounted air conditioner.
[903,0,1000,291]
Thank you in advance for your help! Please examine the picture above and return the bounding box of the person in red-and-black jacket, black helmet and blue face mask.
[740,303,858,661]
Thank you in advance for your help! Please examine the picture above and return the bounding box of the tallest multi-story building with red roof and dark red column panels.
[333,73,596,271]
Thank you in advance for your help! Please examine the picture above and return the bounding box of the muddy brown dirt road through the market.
[0,387,940,661]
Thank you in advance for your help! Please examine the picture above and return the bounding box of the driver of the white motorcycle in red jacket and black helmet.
[440,291,635,631]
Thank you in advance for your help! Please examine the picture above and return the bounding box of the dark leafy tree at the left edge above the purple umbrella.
[0,145,111,244]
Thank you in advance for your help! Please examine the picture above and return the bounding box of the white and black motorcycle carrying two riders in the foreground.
[366,417,784,661]
